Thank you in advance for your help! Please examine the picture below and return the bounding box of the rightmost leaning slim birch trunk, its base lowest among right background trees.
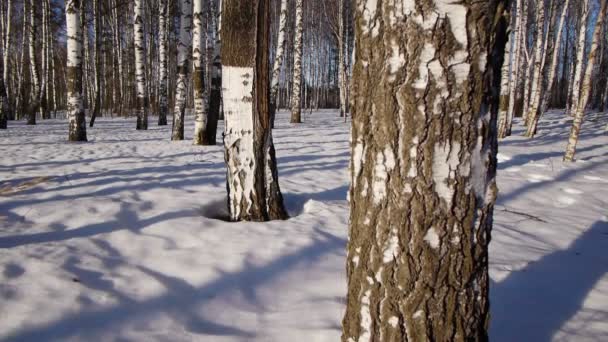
[564,0,608,162]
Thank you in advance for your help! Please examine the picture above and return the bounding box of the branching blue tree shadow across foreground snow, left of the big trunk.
[6,230,346,341]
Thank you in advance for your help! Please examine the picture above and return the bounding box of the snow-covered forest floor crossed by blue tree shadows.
[0,111,608,342]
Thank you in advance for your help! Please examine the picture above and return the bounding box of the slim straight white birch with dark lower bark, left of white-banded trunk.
[192,0,207,145]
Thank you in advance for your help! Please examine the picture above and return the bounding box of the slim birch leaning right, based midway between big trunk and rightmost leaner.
[526,0,570,138]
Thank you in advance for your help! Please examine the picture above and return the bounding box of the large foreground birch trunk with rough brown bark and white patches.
[342,0,509,342]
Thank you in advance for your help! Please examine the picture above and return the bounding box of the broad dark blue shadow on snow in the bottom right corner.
[490,221,608,342]
